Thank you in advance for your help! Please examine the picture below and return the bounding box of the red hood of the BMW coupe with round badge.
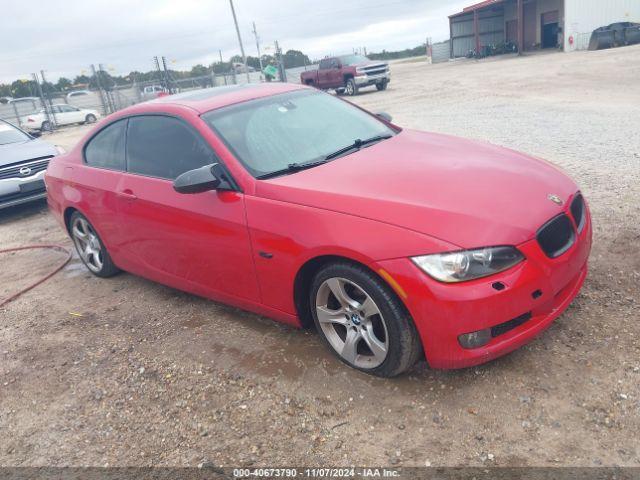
[256,130,577,248]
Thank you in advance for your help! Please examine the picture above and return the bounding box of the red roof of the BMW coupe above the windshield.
[148,82,309,113]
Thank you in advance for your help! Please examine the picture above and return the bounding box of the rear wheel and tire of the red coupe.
[69,212,120,278]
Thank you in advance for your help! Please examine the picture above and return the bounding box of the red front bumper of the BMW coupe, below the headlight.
[378,208,592,369]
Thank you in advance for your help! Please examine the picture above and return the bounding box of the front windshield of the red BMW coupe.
[202,90,395,177]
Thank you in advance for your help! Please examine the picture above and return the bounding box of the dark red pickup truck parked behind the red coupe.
[300,55,391,95]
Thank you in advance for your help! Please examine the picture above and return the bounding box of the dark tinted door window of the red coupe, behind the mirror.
[127,115,215,180]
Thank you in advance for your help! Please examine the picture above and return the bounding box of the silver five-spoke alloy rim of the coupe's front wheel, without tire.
[315,278,389,369]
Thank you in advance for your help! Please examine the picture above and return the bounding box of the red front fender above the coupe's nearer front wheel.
[245,196,453,314]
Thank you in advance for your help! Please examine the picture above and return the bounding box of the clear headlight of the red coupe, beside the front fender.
[411,247,524,283]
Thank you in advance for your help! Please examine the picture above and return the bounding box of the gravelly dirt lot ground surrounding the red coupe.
[0,46,640,466]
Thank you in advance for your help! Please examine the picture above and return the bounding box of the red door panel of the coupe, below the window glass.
[117,174,259,301]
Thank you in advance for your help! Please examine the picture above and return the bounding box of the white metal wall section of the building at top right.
[564,0,640,52]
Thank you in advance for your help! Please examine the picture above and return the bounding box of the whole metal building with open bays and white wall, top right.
[449,0,640,58]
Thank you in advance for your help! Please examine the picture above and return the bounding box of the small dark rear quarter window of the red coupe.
[84,120,127,170]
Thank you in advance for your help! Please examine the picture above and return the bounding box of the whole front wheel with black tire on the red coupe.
[310,262,422,377]
